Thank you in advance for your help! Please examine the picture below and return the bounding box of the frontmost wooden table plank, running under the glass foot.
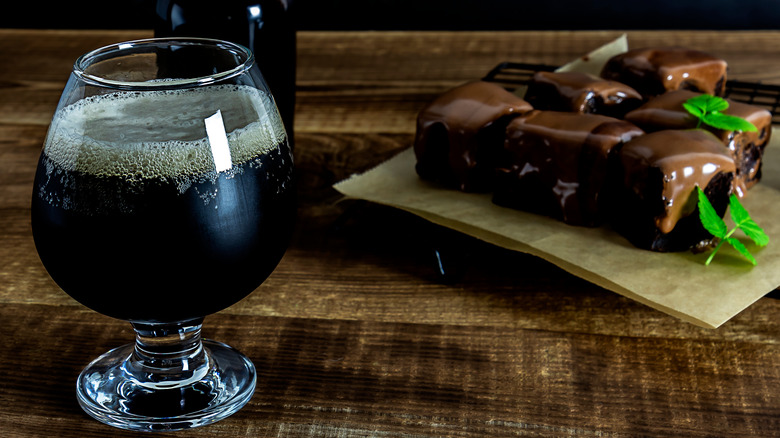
[0,305,780,437]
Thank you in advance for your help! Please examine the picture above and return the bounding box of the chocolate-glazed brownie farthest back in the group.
[601,47,727,98]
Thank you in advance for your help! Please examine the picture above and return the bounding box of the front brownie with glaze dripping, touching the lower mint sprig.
[612,129,736,251]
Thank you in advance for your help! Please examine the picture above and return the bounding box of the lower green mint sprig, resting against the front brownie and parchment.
[696,186,769,265]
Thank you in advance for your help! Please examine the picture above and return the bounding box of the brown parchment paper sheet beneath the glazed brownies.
[334,37,780,328]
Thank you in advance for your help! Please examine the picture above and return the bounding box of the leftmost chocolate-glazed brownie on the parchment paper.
[414,81,532,192]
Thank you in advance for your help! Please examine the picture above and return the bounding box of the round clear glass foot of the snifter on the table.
[77,340,257,431]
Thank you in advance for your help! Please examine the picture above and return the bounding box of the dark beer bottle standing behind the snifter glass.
[154,0,296,146]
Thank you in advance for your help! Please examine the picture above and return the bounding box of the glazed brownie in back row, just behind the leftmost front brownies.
[524,72,643,118]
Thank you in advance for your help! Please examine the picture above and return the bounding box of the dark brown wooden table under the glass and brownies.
[0,30,780,437]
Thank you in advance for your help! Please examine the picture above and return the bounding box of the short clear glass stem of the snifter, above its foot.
[125,318,210,389]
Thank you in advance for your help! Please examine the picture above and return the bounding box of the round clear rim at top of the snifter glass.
[73,37,255,90]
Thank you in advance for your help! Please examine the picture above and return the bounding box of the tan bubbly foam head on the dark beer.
[44,85,286,179]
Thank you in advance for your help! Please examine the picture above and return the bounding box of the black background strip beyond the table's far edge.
[0,0,780,30]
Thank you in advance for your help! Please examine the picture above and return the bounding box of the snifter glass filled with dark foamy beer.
[32,38,295,431]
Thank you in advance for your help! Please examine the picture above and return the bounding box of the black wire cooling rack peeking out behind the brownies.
[482,62,780,125]
